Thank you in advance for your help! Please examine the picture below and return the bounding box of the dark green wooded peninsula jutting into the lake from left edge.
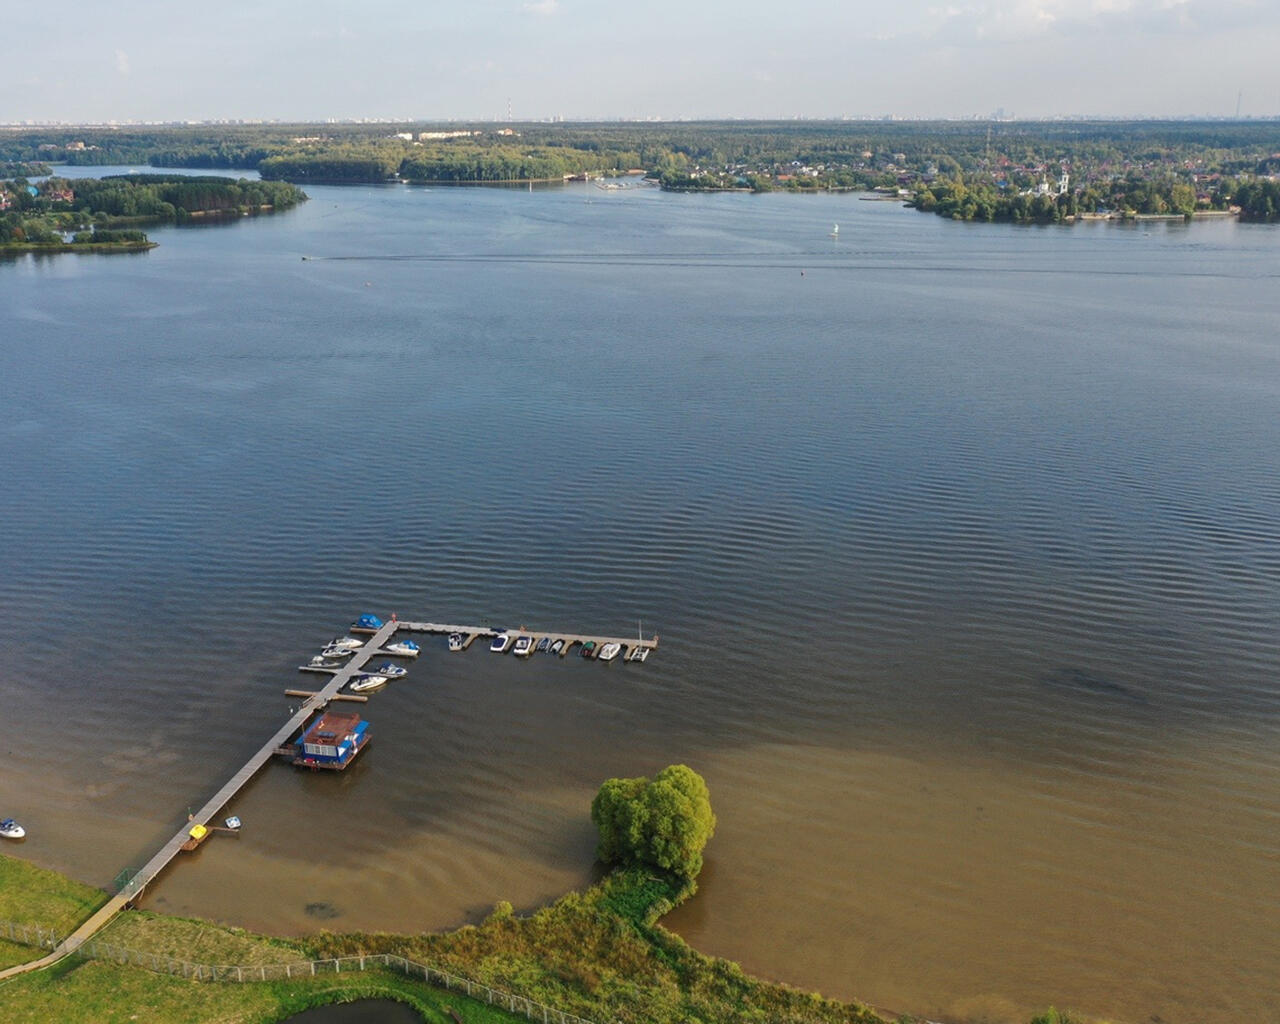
[0,174,306,251]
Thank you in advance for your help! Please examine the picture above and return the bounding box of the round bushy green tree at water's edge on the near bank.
[591,764,716,879]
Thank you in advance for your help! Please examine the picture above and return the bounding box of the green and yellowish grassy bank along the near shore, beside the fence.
[0,855,1100,1024]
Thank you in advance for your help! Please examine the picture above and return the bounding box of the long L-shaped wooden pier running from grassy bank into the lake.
[0,620,658,980]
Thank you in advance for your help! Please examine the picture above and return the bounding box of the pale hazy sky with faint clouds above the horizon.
[0,0,1280,122]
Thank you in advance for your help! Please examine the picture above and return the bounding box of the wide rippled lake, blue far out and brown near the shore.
[0,187,1280,1024]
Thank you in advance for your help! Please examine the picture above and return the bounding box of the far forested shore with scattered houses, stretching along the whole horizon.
[0,122,1280,223]
